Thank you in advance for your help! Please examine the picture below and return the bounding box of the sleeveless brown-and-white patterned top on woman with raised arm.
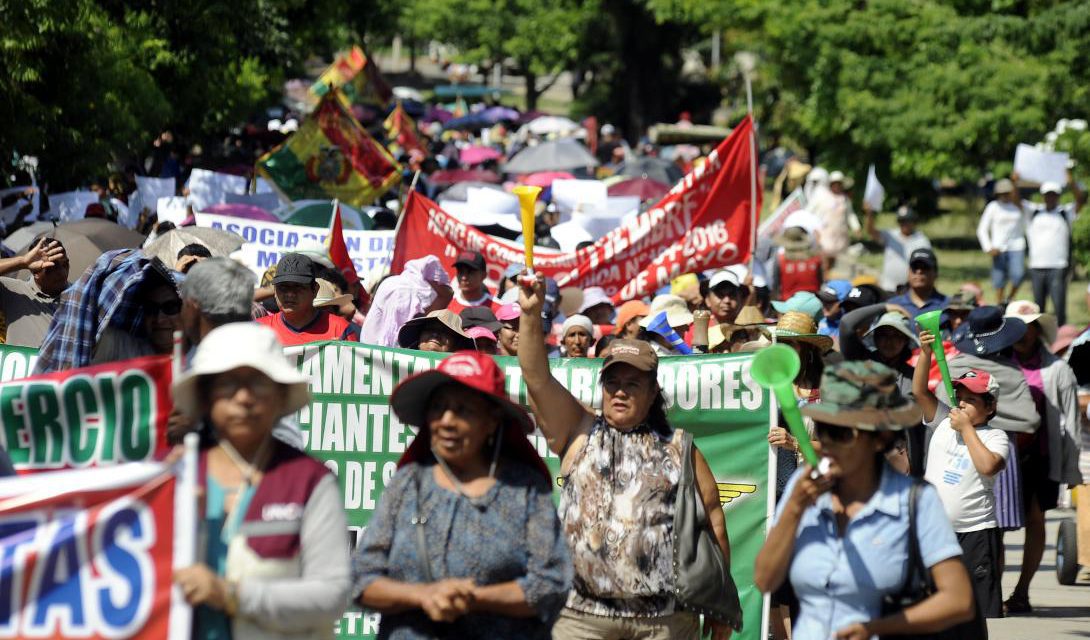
[559,418,681,617]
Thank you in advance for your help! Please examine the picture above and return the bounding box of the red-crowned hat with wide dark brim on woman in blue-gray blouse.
[390,351,549,478]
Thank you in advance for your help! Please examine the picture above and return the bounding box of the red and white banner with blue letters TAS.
[0,463,182,640]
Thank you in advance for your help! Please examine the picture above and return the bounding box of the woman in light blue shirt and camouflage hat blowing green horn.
[754,362,973,640]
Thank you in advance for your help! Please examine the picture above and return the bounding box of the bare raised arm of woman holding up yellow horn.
[519,276,593,457]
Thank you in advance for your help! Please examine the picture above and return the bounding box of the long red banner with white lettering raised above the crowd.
[390,118,761,302]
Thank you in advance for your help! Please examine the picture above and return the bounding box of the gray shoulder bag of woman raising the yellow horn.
[674,432,742,631]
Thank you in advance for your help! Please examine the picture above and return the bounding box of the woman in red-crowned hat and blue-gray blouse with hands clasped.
[352,351,572,639]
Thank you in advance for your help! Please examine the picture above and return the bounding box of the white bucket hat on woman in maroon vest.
[172,323,311,418]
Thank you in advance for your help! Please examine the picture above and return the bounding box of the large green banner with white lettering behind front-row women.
[287,342,770,640]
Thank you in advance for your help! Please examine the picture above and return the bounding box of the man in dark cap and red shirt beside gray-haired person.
[257,253,358,347]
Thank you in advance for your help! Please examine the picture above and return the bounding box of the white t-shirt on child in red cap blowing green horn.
[923,402,1010,533]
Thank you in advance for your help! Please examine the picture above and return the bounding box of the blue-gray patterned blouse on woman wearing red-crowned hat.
[352,461,572,640]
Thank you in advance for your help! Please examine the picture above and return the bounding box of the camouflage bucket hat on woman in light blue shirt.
[802,361,922,431]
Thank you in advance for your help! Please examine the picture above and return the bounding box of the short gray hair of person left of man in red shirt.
[179,257,257,326]
